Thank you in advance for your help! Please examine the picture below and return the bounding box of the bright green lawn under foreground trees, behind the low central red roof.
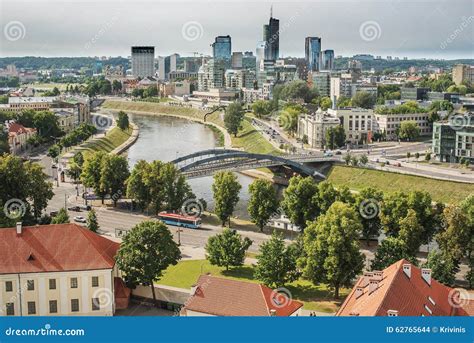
[155,260,349,313]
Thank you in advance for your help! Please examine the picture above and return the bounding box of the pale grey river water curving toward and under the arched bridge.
[128,114,253,218]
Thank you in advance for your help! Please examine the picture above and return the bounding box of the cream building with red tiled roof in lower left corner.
[0,223,129,316]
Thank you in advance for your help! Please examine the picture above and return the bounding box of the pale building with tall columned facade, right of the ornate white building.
[328,108,376,145]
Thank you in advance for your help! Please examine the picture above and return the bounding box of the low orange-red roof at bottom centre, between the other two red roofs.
[184,275,303,316]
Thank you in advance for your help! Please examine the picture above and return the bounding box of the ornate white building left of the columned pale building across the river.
[297,109,340,149]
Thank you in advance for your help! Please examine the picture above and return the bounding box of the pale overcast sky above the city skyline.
[0,0,474,59]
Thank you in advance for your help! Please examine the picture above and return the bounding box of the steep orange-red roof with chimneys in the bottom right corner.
[336,260,466,316]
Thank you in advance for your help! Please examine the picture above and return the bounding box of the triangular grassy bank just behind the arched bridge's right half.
[232,117,281,155]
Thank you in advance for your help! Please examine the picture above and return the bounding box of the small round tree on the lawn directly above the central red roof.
[205,228,252,270]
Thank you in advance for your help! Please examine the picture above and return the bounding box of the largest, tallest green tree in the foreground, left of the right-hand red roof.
[303,202,364,298]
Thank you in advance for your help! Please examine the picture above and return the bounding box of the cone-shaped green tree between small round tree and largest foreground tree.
[254,231,300,287]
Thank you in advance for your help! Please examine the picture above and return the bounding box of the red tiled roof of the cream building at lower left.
[0,224,120,274]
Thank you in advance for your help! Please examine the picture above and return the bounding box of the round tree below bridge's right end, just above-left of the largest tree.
[281,175,320,230]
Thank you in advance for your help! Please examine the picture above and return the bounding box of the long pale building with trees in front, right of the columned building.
[374,111,432,139]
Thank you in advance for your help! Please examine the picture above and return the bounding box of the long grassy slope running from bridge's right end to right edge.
[328,166,474,203]
